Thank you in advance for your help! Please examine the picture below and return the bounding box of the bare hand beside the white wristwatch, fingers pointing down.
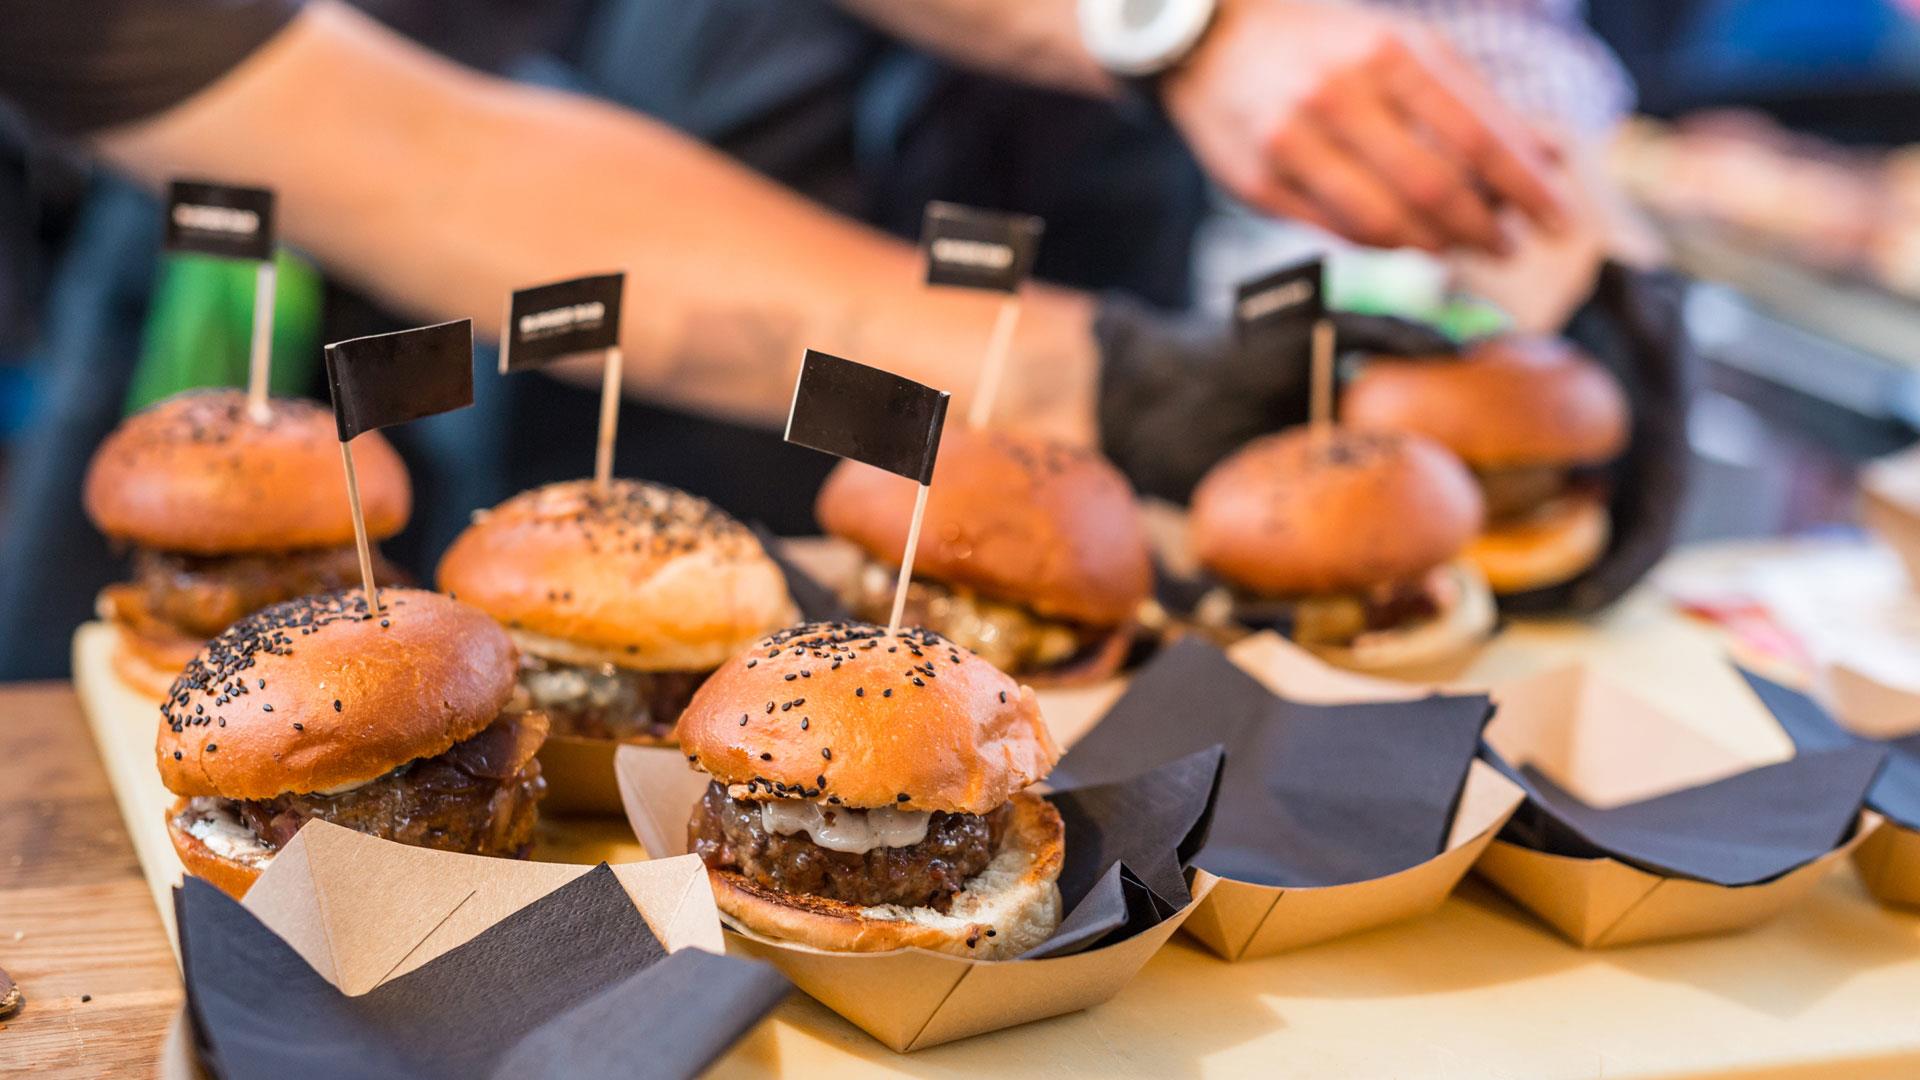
[1162,0,1569,254]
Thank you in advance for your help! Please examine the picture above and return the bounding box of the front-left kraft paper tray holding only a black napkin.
[159,821,724,1080]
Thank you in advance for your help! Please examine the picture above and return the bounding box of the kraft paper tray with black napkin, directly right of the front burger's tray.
[1183,632,1524,961]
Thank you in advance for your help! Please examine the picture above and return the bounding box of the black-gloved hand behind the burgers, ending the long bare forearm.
[1092,294,1455,502]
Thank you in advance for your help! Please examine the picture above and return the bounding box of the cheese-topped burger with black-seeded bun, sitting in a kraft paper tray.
[680,623,1066,959]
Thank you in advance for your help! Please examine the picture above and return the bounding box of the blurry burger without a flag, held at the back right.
[1340,336,1628,594]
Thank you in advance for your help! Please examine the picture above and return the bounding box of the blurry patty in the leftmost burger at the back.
[104,544,405,638]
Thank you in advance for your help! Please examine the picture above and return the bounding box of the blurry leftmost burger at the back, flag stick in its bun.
[84,390,413,696]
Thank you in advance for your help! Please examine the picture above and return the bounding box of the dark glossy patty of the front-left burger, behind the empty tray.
[230,713,547,857]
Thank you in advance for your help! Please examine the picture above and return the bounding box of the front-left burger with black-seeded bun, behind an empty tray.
[156,588,547,897]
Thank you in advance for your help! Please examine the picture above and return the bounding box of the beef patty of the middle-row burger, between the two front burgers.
[520,653,712,742]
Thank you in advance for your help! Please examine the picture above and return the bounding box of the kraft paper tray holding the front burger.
[616,748,1206,1053]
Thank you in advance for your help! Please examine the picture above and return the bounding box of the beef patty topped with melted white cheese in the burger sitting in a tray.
[687,782,1010,911]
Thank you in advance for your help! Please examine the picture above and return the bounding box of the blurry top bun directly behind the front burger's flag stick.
[814,427,1152,626]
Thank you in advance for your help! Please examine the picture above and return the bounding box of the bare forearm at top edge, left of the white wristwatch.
[839,0,1114,96]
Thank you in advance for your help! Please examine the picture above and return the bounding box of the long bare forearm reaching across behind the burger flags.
[100,4,1096,440]
